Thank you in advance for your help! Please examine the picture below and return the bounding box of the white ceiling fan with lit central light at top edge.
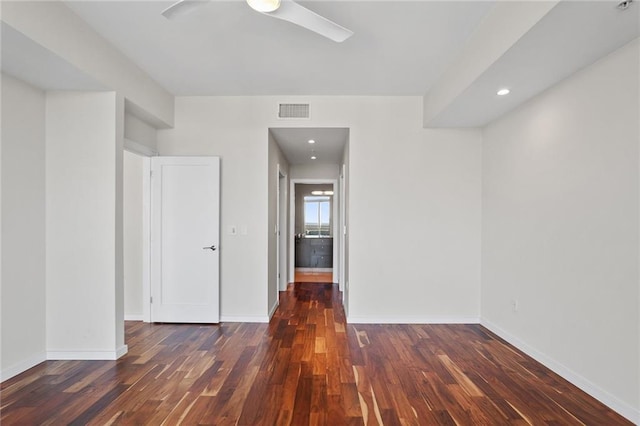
[162,0,353,43]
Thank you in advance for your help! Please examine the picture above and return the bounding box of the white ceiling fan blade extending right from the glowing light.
[261,0,353,43]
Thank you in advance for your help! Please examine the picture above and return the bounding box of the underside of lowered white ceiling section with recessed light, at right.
[429,1,640,127]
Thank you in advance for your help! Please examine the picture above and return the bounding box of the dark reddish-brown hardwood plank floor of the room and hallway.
[0,284,631,425]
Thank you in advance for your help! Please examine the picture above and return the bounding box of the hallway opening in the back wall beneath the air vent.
[268,127,350,309]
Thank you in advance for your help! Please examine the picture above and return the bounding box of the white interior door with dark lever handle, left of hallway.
[151,157,220,323]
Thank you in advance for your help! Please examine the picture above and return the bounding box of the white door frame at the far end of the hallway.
[289,178,343,289]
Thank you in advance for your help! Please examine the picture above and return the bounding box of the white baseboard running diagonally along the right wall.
[480,319,640,424]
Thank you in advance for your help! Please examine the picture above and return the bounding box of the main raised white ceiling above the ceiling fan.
[65,0,493,96]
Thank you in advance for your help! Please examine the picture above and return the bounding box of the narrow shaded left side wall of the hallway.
[267,132,289,317]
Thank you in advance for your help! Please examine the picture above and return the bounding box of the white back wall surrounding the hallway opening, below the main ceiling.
[158,97,481,322]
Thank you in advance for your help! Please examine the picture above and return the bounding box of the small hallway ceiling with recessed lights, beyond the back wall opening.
[269,127,349,165]
